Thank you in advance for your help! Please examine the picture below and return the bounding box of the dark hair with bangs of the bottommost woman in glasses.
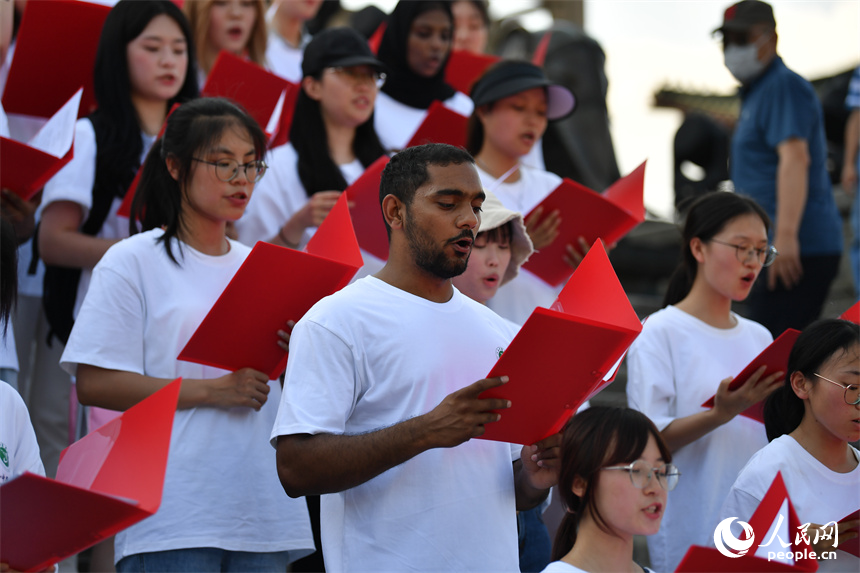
[552,406,672,561]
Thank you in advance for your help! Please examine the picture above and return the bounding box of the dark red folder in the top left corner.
[3,0,110,117]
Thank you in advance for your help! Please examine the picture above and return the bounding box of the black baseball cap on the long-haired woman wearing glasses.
[302,27,387,77]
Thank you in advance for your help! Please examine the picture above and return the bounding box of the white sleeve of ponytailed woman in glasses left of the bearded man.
[60,252,145,375]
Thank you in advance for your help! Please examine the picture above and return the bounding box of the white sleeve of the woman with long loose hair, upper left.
[40,119,96,221]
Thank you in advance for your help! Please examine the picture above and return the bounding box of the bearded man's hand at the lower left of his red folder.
[423,376,511,448]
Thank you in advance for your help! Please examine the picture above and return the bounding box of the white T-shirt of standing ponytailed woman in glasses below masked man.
[627,306,773,571]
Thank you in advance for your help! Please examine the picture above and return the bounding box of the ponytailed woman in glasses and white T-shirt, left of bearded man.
[60,98,314,572]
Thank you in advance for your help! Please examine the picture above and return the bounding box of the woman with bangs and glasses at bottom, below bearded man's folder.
[544,406,681,573]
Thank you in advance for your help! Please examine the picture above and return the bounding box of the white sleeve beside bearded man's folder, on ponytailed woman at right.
[627,322,677,431]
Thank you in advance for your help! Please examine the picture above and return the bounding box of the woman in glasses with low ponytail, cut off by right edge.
[721,319,860,571]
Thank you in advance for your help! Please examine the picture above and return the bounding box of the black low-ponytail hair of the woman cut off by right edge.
[764,318,860,442]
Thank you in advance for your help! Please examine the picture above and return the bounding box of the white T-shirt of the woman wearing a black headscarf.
[373,92,475,151]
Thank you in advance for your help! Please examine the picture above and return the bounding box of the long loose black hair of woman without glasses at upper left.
[90,0,198,204]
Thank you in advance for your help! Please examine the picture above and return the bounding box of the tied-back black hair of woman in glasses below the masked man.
[663,191,770,306]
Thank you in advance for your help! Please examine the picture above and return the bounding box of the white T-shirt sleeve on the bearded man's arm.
[271,320,360,445]
